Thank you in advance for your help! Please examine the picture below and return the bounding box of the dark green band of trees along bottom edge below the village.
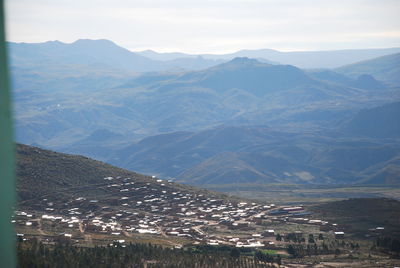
[18,239,281,268]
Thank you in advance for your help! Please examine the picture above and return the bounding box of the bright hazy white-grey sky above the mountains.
[6,0,400,53]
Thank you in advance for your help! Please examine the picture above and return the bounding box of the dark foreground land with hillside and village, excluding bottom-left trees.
[12,145,400,267]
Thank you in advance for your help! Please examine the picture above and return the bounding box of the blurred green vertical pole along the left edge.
[0,0,16,268]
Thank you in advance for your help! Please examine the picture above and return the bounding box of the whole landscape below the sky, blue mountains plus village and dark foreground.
[9,39,400,267]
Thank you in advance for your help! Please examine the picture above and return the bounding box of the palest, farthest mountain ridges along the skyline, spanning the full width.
[9,39,400,74]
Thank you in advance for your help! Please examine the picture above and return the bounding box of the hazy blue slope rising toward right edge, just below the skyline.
[335,53,400,87]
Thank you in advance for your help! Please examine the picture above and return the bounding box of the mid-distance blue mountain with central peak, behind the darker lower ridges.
[12,54,392,149]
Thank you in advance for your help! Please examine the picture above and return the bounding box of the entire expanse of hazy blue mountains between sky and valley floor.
[10,40,400,188]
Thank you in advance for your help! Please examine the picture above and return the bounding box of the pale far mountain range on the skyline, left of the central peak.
[8,39,222,74]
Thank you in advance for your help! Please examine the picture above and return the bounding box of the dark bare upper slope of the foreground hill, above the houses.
[16,144,220,201]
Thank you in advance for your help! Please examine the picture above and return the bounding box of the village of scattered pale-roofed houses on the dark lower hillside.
[12,177,362,249]
